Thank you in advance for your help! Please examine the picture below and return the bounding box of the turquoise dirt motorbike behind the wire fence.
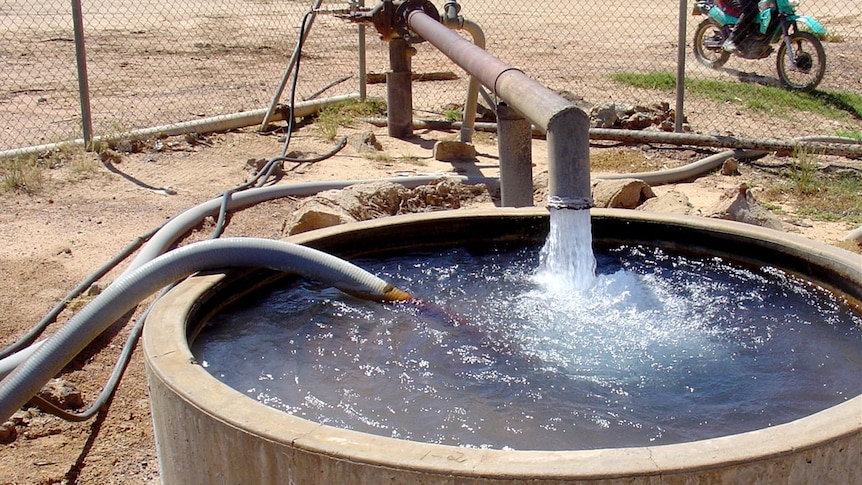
[692,0,826,91]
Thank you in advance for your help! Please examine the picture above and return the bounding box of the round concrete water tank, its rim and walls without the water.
[143,208,862,484]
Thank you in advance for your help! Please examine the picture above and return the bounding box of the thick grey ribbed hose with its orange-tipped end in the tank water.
[0,238,412,422]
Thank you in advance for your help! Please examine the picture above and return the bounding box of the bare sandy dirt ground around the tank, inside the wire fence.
[0,115,858,484]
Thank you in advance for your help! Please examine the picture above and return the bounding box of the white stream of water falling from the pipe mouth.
[536,209,596,293]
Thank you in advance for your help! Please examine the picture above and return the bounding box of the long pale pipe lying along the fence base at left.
[0,93,359,159]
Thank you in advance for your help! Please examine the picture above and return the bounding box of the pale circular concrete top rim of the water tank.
[143,208,862,479]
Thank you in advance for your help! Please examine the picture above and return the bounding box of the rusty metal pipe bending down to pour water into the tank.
[407,9,592,209]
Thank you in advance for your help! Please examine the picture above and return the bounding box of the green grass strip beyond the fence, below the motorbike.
[610,72,862,119]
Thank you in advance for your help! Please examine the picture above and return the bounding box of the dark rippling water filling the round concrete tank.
[193,211,862,450]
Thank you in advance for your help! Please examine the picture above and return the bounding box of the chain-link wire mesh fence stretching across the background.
[0,0,862,150]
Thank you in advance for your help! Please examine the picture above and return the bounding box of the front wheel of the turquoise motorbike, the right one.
[776,32,826,92]
